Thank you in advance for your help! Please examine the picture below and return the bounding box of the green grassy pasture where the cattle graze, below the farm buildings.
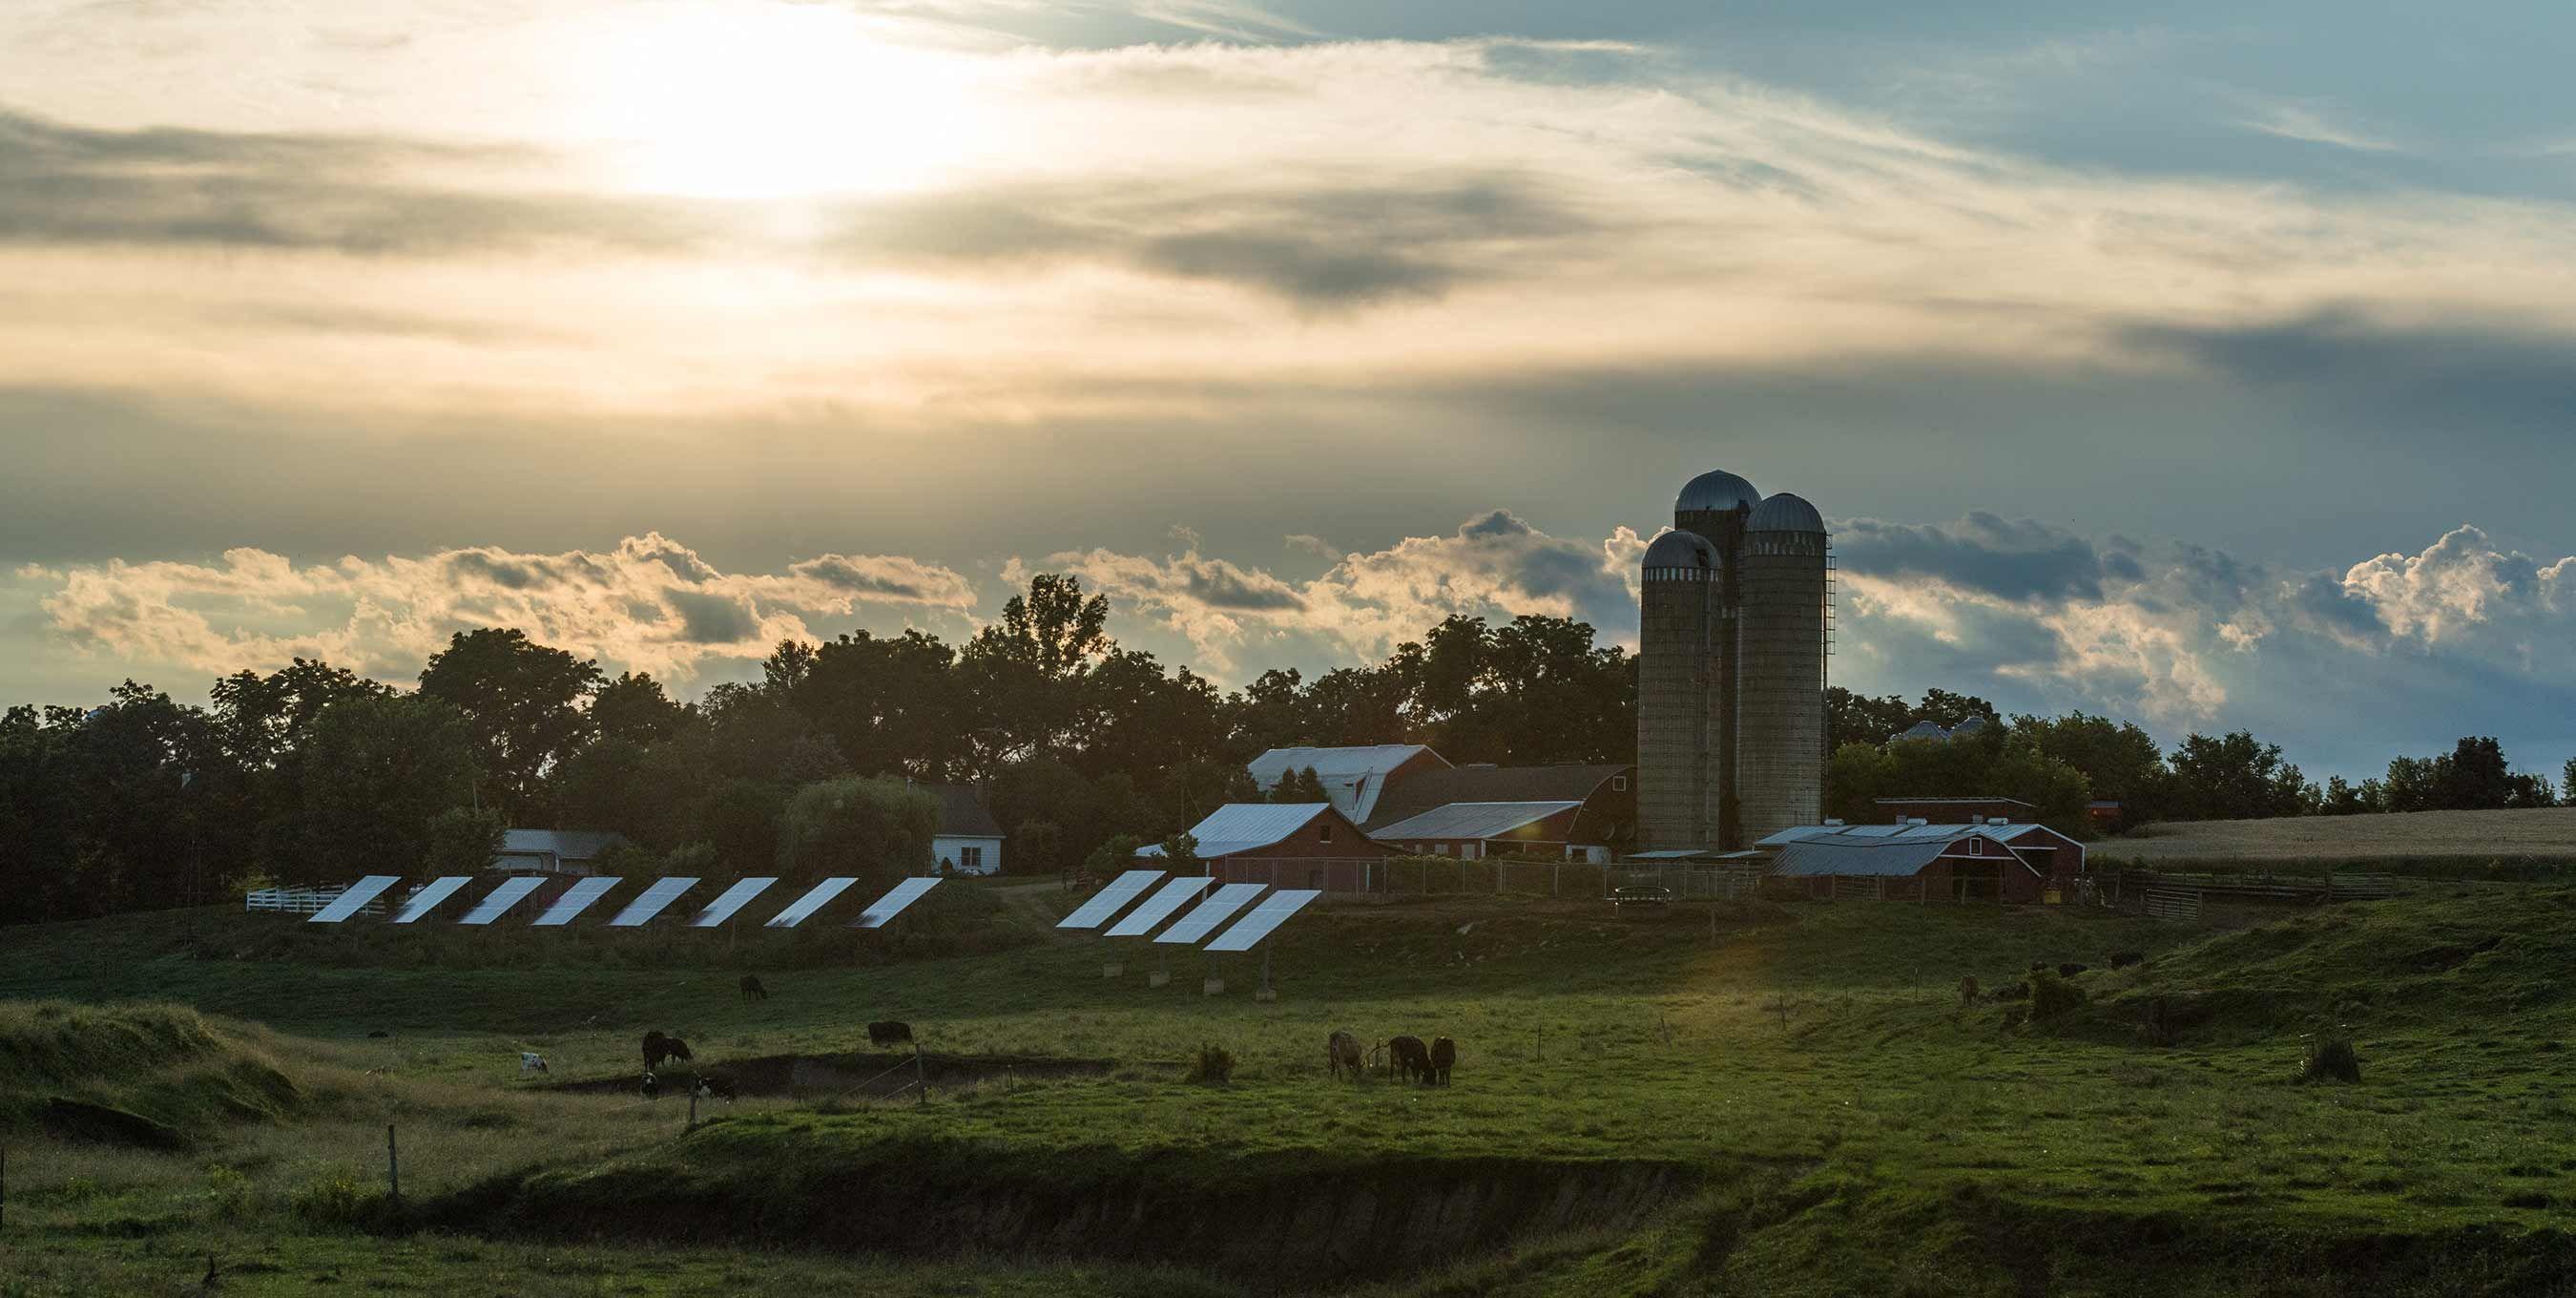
[0,889,2576,1298]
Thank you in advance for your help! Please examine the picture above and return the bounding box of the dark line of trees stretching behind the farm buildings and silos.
[0,575,2576,922]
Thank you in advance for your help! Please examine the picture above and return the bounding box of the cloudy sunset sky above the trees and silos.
[0,0,2576,778]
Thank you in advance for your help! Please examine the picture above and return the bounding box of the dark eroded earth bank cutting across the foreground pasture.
[430,1123,1700,1288]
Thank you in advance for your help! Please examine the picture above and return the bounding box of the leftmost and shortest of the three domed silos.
[1636,531,1721,849]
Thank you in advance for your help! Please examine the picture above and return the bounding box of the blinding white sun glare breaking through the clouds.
[577,5,976,199]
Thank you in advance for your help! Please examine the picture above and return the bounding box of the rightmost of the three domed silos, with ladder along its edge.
[1734,492,1826,845]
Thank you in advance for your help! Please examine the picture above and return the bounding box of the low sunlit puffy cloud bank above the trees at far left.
[21,534,974,680]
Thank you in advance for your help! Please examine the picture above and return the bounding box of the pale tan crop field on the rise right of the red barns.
[2091,806,2576,866]
